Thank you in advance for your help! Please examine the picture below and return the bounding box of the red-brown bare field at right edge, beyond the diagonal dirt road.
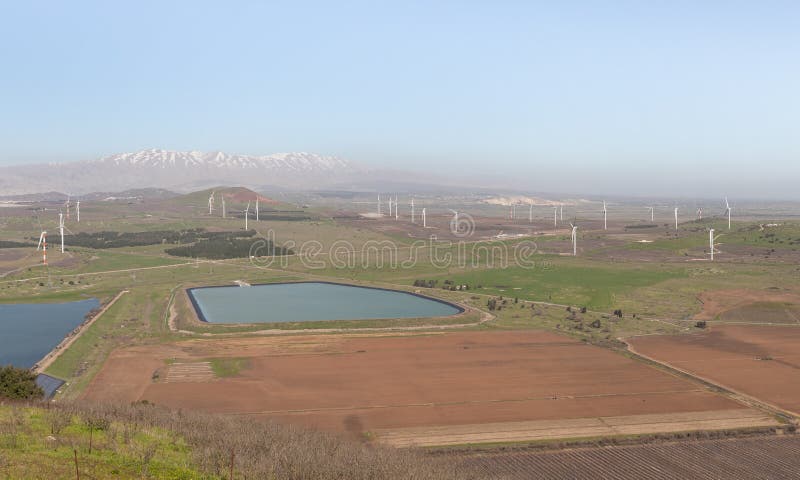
[630,325,800,412]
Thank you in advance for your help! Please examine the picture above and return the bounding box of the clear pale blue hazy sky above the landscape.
[0,0,800,197]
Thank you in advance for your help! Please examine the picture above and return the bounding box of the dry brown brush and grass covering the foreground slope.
[0,403,486,480]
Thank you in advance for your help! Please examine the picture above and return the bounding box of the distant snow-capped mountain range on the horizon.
[0,149,378,196]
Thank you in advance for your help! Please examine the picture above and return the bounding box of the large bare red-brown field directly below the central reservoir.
[85,331,768,444]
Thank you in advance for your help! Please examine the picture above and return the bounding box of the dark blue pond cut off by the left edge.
[0,298,100,368]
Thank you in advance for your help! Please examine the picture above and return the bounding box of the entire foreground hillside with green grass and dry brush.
[0,403,478,480]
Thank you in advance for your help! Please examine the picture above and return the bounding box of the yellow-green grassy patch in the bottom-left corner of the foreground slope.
[0,406,212,480]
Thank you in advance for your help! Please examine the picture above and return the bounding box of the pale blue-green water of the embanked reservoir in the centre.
[189,282,463,323]
